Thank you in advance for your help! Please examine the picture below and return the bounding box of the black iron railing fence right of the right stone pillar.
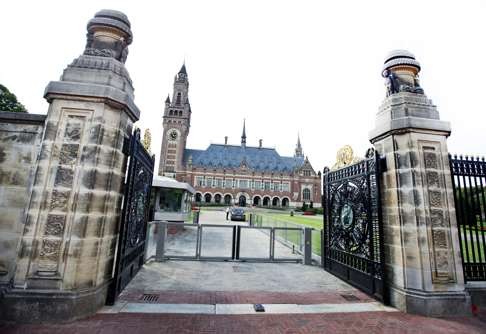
[449,155,486,281]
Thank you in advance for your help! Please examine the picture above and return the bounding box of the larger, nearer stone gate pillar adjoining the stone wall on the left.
[0,10,139,322]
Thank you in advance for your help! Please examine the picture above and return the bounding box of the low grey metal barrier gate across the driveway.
[146,221,312,264]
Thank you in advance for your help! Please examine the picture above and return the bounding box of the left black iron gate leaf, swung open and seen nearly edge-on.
[107,129,154,305]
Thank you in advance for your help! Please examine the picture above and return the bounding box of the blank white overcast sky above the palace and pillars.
[0,0,486,170]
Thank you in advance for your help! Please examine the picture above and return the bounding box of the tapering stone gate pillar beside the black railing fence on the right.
[370,50,470,316]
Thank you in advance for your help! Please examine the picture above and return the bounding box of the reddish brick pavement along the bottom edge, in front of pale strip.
[0,312,486,334]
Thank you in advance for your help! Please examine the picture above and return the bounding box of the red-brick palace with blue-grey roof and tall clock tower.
[159,65,321,207]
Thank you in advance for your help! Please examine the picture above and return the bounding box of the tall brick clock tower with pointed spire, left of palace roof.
[159,64,191,178]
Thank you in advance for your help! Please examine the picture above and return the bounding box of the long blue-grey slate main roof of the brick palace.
[184,144,304,172]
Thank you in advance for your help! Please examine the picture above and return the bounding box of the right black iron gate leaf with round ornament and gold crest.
[322,149,386,302]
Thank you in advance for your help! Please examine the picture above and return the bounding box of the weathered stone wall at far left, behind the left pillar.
[0,112,46,285]
